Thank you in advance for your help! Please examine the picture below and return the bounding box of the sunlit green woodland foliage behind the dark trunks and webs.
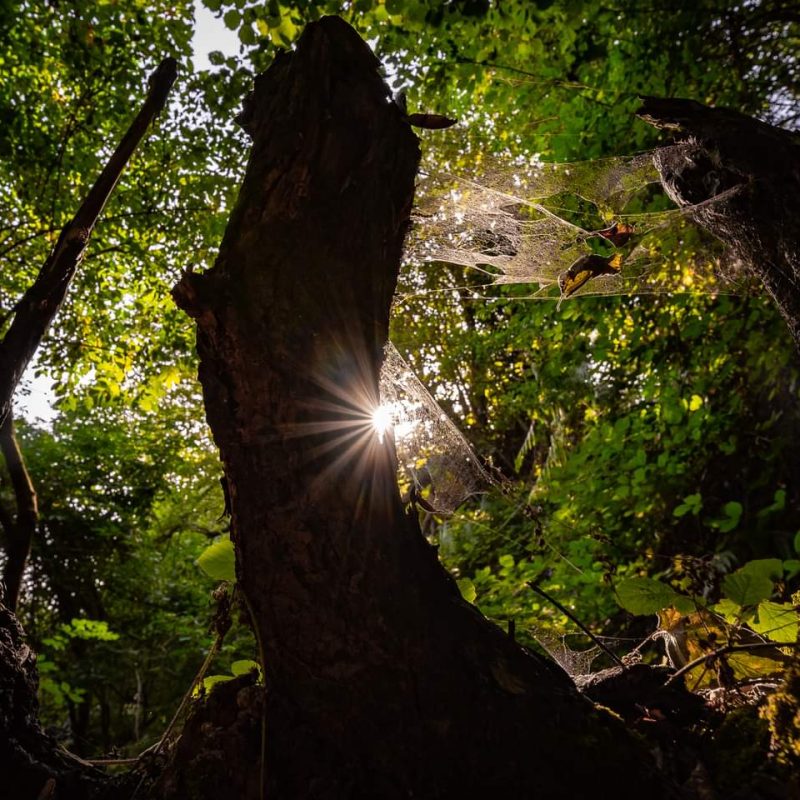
[0,0,800,784]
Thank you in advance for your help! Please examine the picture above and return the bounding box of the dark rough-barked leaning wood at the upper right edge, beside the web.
[639,97,800,349]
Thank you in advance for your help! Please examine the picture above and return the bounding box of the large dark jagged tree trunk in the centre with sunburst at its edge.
[170,18,663,800]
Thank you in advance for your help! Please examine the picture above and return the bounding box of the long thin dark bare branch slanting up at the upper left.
[0,58,177,432]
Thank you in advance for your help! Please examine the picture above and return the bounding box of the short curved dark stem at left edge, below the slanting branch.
[0,414,39,611]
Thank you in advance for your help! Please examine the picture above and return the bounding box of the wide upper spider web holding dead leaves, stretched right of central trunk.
[407,145,750,297]
